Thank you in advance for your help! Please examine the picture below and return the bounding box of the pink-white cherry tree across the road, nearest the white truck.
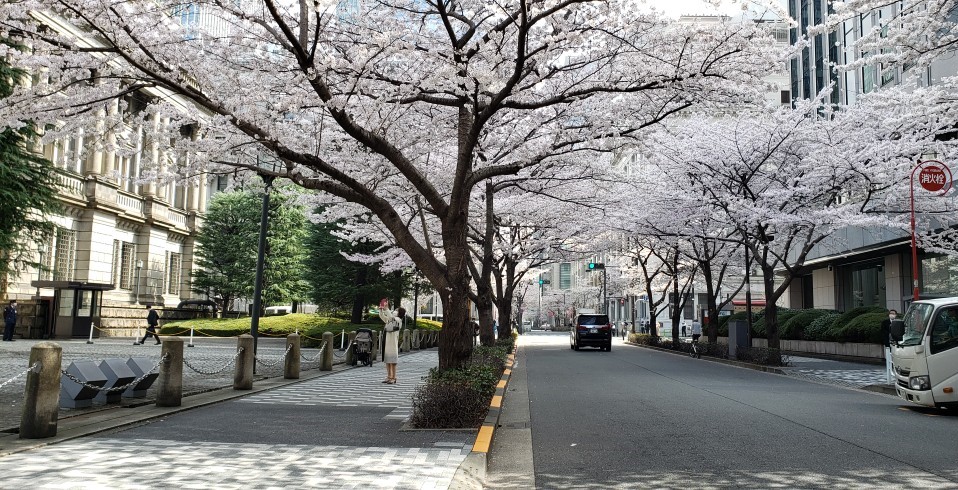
[636,91,952,360]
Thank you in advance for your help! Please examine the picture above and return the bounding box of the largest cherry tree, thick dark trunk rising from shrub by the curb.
[0,0,788,369]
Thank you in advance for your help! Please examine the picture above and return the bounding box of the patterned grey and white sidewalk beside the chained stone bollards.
[0,350,475,489]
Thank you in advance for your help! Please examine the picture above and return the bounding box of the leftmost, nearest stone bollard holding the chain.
[20,342,63,439]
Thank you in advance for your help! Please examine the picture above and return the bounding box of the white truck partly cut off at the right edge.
[891,297,958,409]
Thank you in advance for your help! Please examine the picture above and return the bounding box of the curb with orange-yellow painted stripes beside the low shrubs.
[449,350,516,490]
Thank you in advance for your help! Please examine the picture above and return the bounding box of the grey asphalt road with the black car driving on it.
[519,332,958,489]
